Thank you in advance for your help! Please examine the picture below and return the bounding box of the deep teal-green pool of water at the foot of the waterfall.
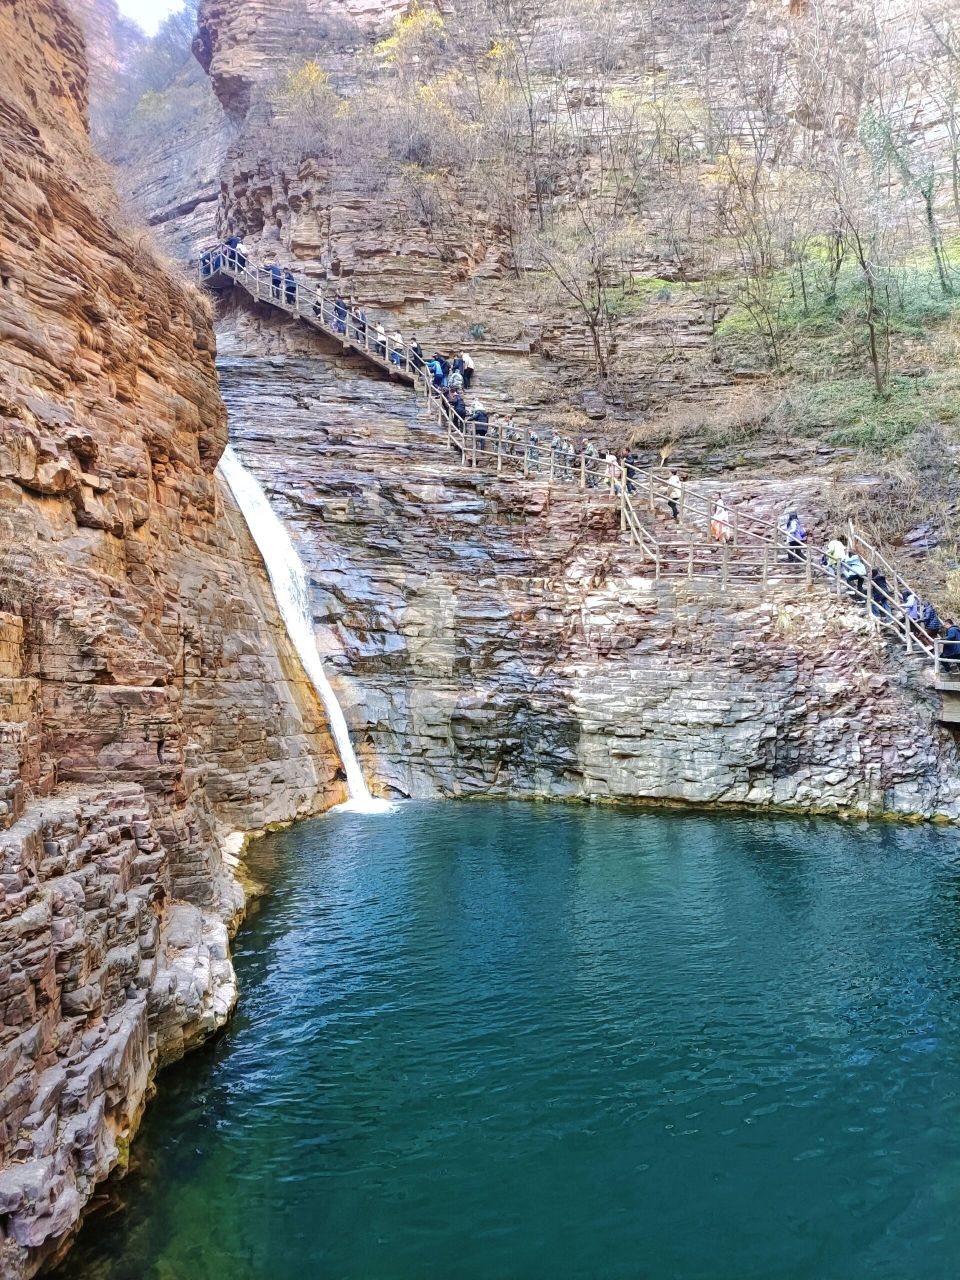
[56,804,960,1280]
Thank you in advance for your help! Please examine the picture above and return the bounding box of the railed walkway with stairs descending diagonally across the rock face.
[197,243,960,678]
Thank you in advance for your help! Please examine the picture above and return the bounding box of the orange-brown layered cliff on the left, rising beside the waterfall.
[0,0,343,1276]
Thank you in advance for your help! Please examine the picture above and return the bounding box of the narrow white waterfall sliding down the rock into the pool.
[219,444,392,813]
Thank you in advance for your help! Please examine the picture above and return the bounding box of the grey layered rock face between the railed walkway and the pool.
[221,326,960,817]
